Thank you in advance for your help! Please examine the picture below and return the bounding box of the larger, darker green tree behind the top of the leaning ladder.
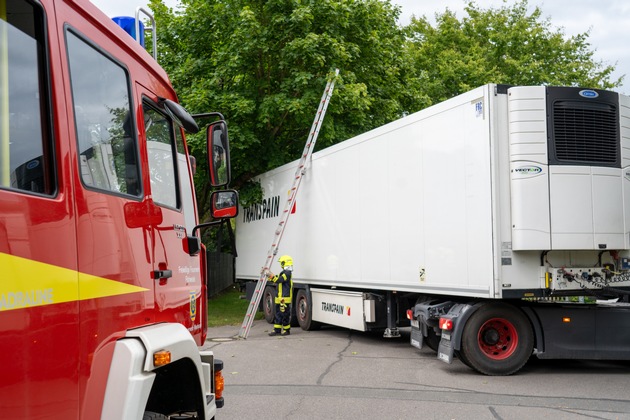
[150,0,406,217]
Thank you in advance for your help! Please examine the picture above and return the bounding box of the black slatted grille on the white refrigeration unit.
[553,100,620,166]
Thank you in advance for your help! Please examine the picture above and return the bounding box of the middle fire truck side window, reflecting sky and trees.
[66,31,141,196]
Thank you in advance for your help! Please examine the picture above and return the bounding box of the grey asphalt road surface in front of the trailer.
[205,320,630,420]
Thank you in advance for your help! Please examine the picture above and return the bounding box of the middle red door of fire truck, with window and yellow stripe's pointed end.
[65,27,155,418]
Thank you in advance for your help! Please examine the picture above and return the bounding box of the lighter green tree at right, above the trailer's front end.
[406,0,622,103]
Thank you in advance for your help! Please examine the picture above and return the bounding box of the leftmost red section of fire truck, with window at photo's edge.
[0,0,79,419]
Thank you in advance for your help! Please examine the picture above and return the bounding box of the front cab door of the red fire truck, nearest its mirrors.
[141,92,205,335]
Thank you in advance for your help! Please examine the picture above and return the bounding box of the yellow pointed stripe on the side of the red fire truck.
[0,253,149,311]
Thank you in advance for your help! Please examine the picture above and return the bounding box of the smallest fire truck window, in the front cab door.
[144,104,179,208]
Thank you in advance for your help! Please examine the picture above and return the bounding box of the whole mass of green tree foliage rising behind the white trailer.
[150,0,621,236]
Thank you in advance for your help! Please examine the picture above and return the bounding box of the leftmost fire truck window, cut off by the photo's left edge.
[0,0,56,194]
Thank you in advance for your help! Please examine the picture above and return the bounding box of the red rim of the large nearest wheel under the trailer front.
[477,318,518,360]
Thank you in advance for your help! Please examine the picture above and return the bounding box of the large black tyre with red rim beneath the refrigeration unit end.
[460,304,534,376]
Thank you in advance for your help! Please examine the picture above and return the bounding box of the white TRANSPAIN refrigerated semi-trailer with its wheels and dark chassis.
[236,84,630,375]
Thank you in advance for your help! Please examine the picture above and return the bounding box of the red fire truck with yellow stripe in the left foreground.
[0,0,238,420]
